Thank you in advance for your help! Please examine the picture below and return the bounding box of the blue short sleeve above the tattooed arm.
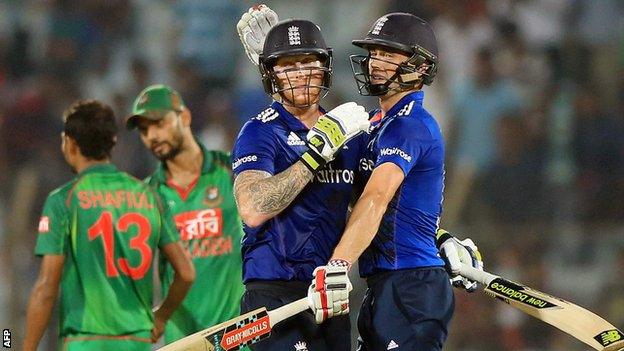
[232,120,276,175]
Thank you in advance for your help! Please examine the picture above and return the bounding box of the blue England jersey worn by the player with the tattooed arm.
[232,102,368,282]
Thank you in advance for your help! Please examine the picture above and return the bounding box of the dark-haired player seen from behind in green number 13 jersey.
[24,100,195,351]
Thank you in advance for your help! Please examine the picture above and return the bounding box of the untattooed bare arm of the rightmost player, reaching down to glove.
[332,163,404,262]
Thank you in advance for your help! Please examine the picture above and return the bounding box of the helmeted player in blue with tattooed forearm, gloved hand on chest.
[232,13,369,351]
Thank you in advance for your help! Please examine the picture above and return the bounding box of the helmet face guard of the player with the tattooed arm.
[258,49,333,107]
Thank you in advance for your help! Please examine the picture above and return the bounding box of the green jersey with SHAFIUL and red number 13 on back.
[35,164,177,336]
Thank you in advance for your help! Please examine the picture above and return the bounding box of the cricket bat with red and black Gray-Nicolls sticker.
[158,297,309,351]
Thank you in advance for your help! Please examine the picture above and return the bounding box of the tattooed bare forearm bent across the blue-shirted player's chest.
[234,161,313,227]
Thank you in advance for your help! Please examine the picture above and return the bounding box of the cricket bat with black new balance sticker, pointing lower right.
[461,264,624,351]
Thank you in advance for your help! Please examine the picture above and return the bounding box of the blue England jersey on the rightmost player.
[359,91,444,277]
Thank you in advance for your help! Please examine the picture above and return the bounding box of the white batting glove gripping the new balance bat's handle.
[436,229,483,292]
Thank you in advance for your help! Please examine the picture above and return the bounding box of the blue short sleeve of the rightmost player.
[375,118,431,175]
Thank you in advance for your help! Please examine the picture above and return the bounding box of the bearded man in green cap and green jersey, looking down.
[126,85,243,343]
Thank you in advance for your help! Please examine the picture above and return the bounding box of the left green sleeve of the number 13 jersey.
[35,192,70,256]
